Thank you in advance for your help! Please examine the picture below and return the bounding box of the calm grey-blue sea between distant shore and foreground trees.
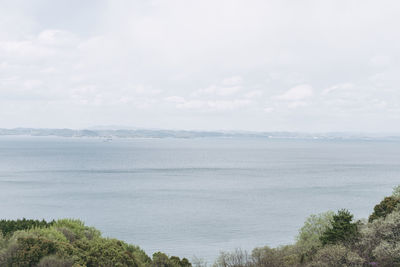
[0,137,400,262]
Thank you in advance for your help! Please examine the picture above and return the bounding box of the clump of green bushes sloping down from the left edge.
[0,219,191,267]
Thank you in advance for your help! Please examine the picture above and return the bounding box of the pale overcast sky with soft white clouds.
[0,0,400,133]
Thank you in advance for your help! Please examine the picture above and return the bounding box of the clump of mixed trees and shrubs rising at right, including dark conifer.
[214,186,400,267]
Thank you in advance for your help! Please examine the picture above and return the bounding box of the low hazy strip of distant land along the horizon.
[0,126,400,140]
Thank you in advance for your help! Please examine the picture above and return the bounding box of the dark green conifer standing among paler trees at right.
[320,209,358,245]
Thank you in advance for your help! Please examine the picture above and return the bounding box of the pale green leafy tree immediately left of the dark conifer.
[297,211,335,254]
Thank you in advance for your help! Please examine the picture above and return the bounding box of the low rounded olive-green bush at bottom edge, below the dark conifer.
[307,245,365,267]
